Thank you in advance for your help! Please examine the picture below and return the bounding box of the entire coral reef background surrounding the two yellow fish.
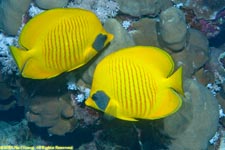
[0,0,225,150]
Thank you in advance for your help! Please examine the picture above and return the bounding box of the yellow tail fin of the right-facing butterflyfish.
[10,46,28,71]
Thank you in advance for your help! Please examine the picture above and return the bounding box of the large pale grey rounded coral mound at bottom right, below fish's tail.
[164,79,219,150]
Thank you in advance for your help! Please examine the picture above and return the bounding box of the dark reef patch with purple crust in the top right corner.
[177,0,225,38]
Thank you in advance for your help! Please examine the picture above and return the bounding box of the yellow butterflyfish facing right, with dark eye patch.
[10,8,113,79]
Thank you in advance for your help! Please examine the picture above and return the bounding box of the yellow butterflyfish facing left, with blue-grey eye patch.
[85,46,183,121]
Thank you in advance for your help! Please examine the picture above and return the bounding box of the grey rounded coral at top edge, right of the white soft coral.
[116,0,172,17]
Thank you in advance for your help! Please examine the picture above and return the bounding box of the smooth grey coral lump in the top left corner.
[0,0,31,35]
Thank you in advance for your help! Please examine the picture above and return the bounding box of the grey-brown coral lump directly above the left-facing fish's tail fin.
[172,29,209,77]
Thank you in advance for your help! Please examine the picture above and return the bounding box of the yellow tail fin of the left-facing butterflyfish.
[168,67,184,95]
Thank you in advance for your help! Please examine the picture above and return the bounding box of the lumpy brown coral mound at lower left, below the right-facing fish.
[26,90,99,135]
